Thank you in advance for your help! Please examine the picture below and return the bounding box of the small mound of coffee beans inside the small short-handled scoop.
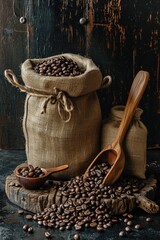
[19,164,45,178]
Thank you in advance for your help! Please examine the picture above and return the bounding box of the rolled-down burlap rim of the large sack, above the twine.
[21,53,102,97]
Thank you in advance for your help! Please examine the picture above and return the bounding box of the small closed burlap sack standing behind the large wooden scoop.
[101,106,147,179]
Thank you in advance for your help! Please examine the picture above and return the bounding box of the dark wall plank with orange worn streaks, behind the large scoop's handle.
[87,0,160,147]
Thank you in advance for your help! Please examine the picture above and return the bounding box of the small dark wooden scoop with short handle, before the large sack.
[14,164,68,189]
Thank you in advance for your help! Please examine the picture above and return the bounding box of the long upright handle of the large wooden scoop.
[113,71,149,145]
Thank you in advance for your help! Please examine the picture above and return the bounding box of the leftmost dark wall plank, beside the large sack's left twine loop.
[0,0,28,149]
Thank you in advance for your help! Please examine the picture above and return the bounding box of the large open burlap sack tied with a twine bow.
[5,53,110,180]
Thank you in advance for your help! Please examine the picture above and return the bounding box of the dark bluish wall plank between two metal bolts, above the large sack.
[28,0,86,57]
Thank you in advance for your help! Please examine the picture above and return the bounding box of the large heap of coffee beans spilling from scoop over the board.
[33,163,143,231]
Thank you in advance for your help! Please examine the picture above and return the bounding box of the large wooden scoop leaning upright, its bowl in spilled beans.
[83,71,149,185]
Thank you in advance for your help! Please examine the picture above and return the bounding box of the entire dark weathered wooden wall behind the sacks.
[0,0,160,149]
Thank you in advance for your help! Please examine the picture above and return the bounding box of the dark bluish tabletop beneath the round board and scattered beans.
[0,150,160,240]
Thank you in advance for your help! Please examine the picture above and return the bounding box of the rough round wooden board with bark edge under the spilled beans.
[5,163,159,214]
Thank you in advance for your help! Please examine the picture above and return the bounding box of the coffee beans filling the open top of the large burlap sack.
[34,56,84,77]
